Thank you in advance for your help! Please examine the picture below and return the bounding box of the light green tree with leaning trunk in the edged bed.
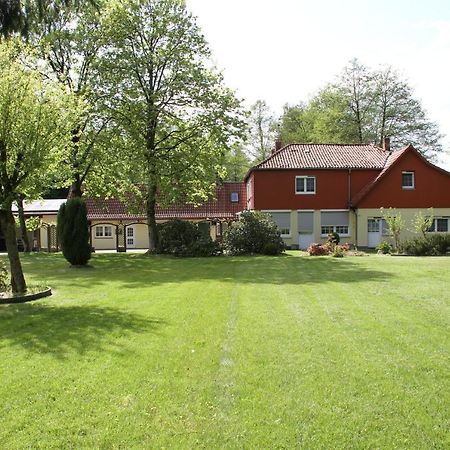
[0,42,81,292]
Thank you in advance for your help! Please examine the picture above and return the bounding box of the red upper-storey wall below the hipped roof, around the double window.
[253,169,380,210]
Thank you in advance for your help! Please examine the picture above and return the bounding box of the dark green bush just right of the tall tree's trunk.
[157,219,220,256]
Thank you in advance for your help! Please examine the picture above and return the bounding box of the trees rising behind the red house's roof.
[281,60,441,155]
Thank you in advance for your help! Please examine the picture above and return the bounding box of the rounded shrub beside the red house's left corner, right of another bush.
[223,211,286,255]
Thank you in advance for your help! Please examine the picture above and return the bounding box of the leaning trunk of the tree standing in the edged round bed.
[0,204,27,293]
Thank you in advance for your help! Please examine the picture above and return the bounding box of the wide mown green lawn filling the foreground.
[0,252,450,450]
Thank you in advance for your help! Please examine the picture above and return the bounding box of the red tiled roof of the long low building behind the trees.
[86,183,246,220]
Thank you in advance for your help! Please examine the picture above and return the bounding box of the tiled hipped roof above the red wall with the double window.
[247,144,388,176]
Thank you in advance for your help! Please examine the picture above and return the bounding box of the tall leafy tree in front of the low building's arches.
[97,0,248,252]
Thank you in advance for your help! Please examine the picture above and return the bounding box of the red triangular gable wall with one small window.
[357,149,450,208]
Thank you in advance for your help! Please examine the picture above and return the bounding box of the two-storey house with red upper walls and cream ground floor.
[245,140,450,248]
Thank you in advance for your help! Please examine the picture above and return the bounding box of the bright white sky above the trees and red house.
[186,0,450,171]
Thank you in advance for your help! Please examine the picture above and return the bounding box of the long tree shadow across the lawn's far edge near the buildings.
[10,254,395,288]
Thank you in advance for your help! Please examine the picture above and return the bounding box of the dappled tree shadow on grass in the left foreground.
[0,303,166,359]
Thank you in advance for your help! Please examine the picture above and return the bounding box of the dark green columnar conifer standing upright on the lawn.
[57,198,91,266]
